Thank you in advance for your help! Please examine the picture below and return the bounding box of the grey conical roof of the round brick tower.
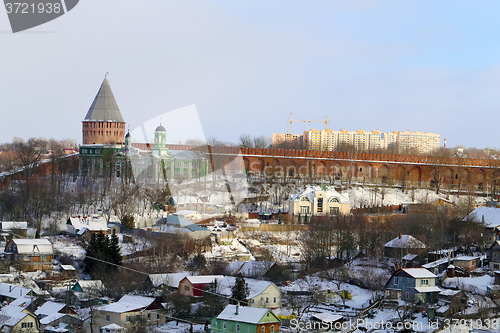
[84,78,124,123]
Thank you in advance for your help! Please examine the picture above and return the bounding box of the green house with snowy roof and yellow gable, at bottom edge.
[210,304,281,333]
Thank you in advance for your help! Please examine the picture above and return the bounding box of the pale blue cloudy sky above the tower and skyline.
[0,0,500,148]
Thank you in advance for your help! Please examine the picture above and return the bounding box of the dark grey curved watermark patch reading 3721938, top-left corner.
[4,0,80,33]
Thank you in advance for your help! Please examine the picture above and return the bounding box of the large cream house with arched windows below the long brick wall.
[288,186,350,222]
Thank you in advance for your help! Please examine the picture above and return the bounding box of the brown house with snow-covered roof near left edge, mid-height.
[5,238,54,271]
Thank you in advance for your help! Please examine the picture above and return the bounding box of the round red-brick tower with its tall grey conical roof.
[82,77,125,145]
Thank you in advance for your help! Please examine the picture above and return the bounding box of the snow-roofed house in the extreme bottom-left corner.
[0,305,41,333]
